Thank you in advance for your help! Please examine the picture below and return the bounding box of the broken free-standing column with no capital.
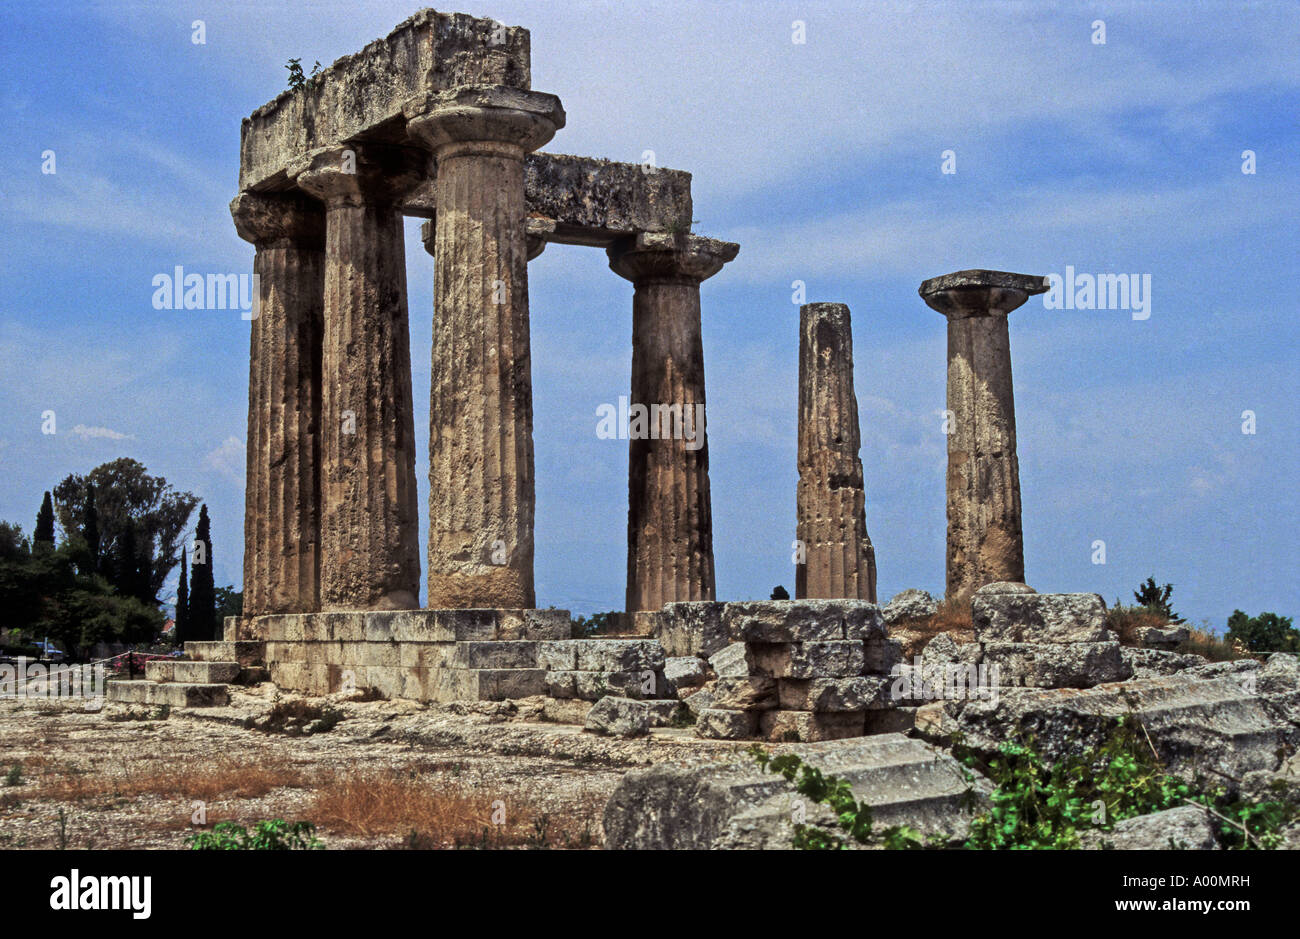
[794,303,876,602]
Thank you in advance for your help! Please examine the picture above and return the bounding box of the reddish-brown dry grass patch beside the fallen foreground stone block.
[306,770,603,848]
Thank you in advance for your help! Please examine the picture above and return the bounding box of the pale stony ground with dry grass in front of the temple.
[0,683,738,849]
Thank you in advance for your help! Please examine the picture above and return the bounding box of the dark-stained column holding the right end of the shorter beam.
[608,233,740,613]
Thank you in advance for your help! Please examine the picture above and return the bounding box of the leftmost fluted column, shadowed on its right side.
[230,192,325,616]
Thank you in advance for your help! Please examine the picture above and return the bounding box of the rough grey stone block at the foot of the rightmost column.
[971,590,1114,642]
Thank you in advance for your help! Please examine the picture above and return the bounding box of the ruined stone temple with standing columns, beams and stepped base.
[112,10,1097,741]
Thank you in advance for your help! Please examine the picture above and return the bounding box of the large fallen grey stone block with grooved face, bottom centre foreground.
[605,734,989,849]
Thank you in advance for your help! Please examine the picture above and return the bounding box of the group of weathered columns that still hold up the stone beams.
[231,87,738,615]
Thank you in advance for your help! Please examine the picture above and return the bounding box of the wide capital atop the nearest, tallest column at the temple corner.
[402,85,564,159]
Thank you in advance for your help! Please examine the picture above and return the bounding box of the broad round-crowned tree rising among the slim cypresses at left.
[53,456,199,602]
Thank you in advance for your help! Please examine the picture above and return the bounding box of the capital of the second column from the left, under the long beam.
[289,143,430,207]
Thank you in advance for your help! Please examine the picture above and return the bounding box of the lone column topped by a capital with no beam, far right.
[919,271,1048,598]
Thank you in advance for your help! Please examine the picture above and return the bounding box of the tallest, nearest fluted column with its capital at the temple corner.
[406,85,564,607]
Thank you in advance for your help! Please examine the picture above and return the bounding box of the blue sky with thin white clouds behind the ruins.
[0,0,1300,626]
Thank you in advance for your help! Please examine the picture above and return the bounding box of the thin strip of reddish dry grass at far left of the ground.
[36,758,307,802]
